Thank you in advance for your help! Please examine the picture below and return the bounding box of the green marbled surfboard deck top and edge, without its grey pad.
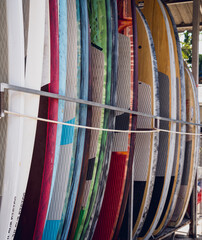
[74,0,111,239]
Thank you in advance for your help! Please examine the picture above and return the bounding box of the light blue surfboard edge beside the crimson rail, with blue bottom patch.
[43,0,67,239]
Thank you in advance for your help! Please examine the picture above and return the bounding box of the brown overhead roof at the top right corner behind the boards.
[165,0,202,32]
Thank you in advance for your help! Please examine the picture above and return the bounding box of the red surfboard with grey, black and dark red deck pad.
[93,1,138,240]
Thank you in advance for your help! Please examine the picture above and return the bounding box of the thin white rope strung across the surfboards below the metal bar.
[4,110,202,136]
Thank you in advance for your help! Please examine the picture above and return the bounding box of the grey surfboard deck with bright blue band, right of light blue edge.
[56,0,81,238]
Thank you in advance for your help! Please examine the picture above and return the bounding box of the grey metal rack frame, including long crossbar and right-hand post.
[0,0,202,239]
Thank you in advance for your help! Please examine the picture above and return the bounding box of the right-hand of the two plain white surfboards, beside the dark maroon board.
[9,0,46,239]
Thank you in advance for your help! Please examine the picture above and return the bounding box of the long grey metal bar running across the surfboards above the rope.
[0,83,202,127]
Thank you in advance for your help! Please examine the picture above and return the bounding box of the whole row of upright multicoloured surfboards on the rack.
[0,0,200,240]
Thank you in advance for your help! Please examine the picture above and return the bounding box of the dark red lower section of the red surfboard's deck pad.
[93,152,128,240]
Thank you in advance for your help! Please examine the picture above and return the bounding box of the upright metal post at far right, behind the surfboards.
[189,0,200,238]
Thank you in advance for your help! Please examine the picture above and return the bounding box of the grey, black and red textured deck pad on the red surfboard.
[93,29,131,239]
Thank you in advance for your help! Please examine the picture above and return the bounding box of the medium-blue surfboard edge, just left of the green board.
[62,0,91,239]
